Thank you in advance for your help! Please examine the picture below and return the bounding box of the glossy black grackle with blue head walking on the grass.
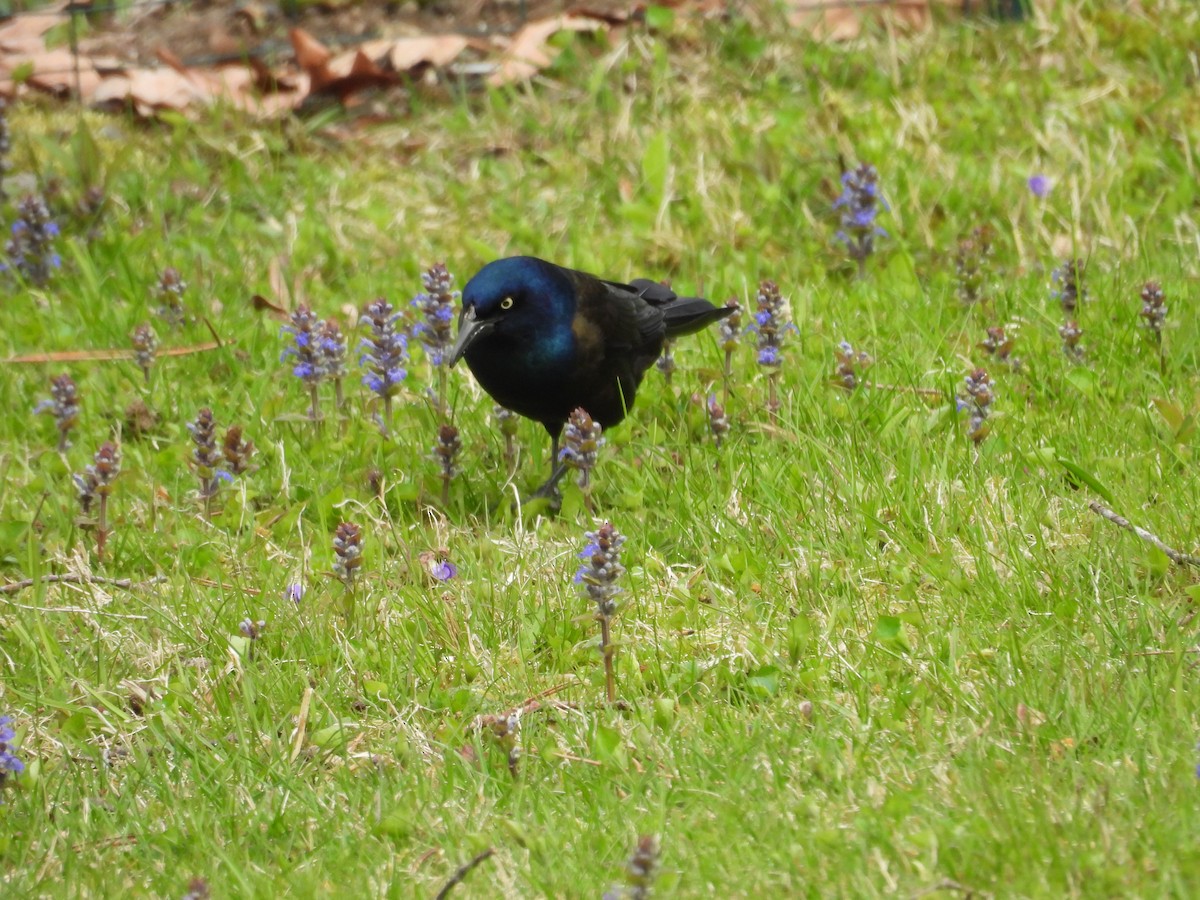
[450,257,732,493]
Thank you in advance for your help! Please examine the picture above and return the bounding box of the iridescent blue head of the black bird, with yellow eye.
[448,257,575,366]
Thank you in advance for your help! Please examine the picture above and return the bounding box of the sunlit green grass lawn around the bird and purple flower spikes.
[0,1,1200,898]
